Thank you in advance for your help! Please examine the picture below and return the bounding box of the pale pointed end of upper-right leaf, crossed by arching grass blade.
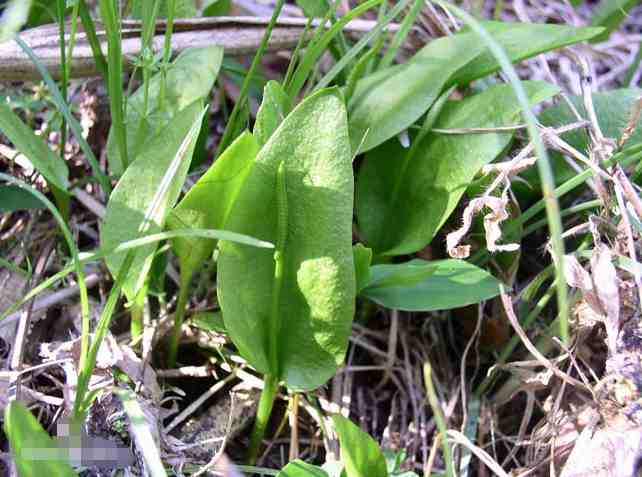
[449,21,603,85]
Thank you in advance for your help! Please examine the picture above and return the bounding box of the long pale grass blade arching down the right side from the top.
[436,0,570,344]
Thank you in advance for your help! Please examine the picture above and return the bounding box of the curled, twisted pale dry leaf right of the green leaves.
[446,191,519,258]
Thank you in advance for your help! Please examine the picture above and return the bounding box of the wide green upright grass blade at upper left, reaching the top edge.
[99,0,129,171]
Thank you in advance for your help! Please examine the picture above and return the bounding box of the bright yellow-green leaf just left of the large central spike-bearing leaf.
[167,132,259,276]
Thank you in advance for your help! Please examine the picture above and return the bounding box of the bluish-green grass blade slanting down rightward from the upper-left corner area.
[15,35,111,196]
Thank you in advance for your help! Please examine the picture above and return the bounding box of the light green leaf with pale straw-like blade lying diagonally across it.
[100,101,203,300]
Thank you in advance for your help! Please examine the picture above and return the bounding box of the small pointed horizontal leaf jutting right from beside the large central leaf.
[360,259,500,311]
